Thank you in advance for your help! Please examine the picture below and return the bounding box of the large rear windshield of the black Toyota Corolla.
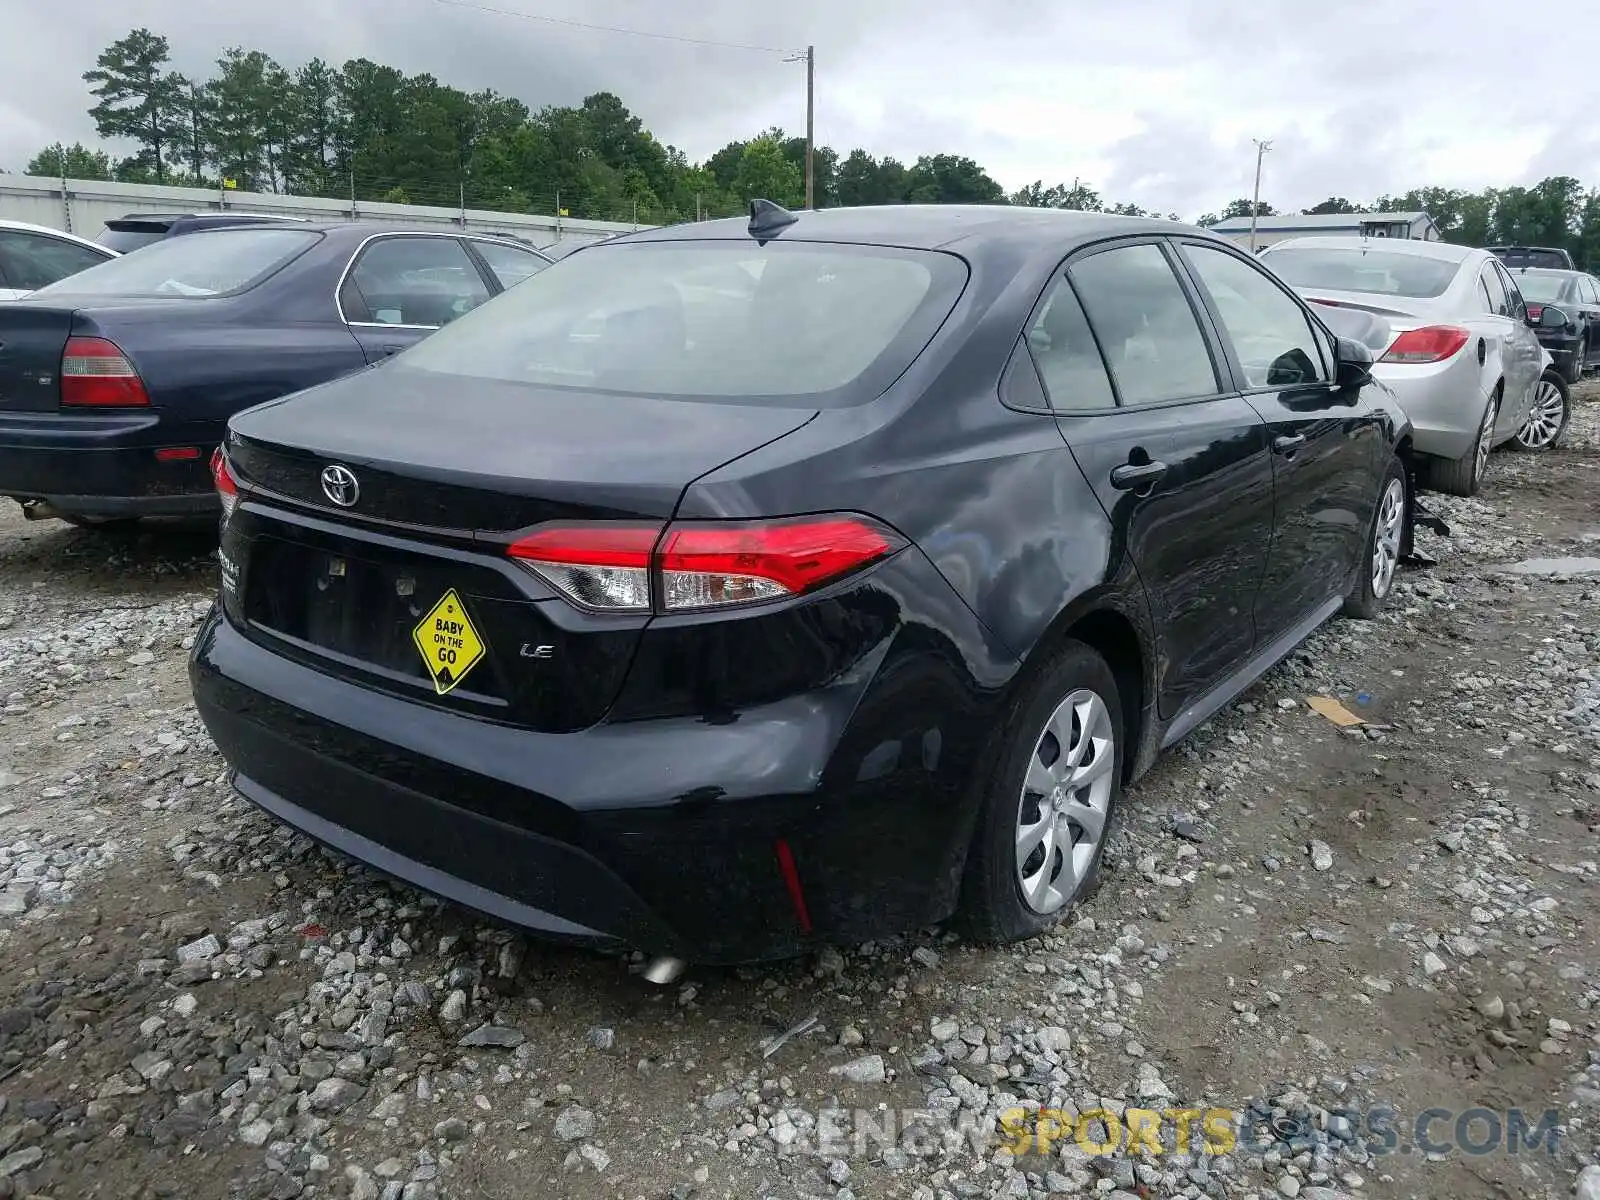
[398,242,966,405]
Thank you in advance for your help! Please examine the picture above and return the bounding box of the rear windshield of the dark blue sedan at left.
[34,229,320,299]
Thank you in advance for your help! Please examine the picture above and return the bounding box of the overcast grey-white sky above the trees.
[0,0,1600,219]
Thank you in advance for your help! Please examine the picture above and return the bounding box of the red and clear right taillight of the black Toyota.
[506,515,904,613]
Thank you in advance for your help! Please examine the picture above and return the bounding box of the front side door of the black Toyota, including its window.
[1181,240,1387,643]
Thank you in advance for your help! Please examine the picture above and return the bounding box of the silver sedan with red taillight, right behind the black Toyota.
[1261,237,1565,496]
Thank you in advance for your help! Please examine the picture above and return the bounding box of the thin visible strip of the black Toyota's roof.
[606,205,1203,253]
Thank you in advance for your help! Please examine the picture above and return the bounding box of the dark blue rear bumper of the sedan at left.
[0,413,222,517]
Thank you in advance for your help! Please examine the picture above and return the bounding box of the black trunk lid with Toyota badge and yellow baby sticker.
[222,363,814,731]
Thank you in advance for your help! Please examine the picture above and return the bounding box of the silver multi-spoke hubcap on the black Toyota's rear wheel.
[1016,688,1117,915]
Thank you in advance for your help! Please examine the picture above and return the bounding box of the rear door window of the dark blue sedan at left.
[348,237,490,328]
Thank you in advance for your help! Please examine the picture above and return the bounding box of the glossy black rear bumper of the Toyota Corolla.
[190,601,998,963]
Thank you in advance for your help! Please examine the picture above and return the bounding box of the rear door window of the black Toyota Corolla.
[1067,245,1221,405]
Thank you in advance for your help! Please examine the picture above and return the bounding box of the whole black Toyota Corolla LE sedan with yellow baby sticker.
[192,202,1411,962]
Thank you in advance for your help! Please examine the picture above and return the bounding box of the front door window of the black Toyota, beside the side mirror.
[1184,245,1328,387]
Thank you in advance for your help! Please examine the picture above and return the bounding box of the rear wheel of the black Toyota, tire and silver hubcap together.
[962,640,1133,942]
